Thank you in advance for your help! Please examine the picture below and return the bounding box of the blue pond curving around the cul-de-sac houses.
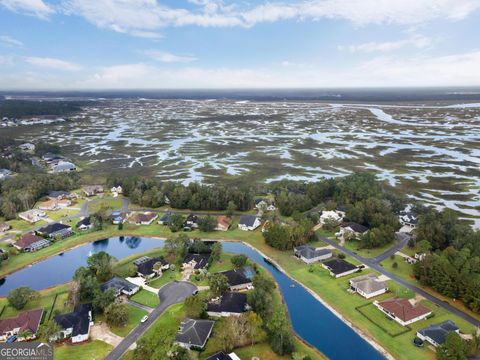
[0,237,383,360]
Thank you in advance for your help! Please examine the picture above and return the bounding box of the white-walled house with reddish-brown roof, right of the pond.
[373,298,432,326]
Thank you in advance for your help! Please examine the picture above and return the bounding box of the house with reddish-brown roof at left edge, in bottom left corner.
[0,309,43,342]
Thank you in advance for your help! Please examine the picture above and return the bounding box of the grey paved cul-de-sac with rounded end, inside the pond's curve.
[105,281,197,360]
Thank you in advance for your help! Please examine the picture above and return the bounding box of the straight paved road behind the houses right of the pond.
[317,234,480,327]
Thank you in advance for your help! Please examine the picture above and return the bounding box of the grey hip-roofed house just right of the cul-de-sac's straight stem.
[175,318,215,349]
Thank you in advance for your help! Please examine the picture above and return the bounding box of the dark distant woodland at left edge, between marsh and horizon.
[0,100,91,118]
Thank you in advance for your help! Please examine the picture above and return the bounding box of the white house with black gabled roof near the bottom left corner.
[50,304,93,344]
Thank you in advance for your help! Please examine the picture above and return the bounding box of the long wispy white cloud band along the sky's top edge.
[59,0,480,35]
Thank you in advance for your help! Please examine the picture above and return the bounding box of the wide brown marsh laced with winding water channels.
[2,99,480,225]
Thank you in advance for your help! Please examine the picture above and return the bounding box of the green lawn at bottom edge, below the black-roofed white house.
[54,340,113,360]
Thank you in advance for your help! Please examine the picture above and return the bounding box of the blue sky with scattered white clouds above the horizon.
[0,0,480,90]
